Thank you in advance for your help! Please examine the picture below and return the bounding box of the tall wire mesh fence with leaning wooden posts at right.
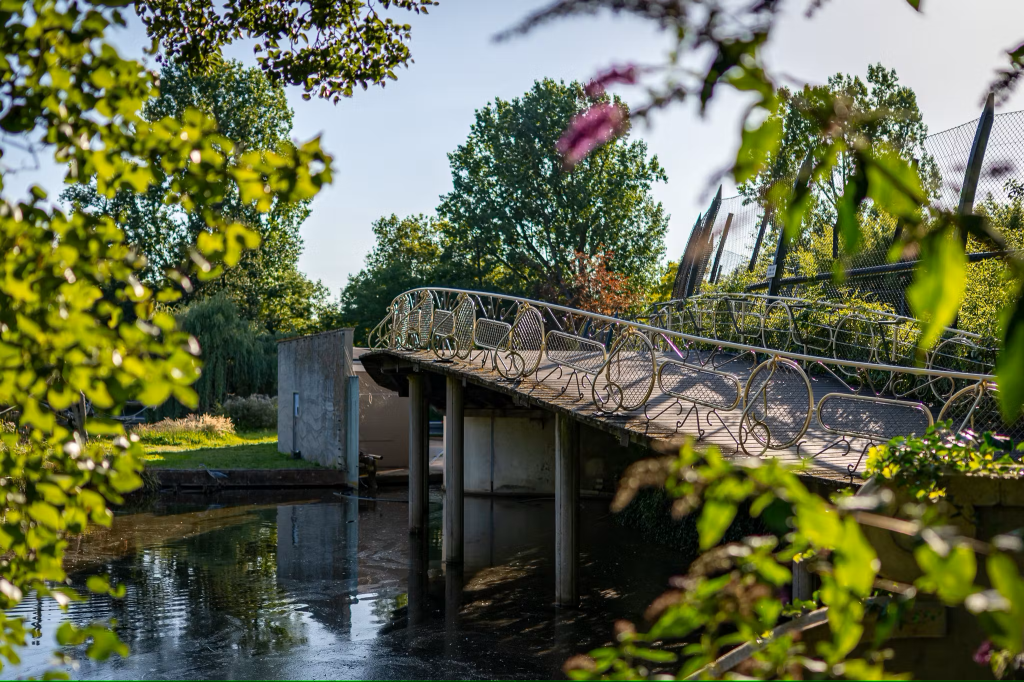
[674,104,1024,325]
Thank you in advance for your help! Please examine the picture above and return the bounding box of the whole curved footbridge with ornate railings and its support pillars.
[362,289,1024,599]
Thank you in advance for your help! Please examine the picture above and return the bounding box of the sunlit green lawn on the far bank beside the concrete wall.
[141,431,318,469]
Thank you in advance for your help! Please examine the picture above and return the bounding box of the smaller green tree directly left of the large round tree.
[340,213,442,344]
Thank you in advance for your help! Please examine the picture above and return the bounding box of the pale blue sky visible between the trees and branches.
[8,0,1024,296]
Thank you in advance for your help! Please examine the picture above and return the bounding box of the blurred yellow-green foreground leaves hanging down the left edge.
[0,0,423,663]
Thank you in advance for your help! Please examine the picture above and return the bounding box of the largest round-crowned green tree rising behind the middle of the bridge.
[437,80,669,303]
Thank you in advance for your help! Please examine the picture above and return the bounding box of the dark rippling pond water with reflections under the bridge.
[0,489,685,679]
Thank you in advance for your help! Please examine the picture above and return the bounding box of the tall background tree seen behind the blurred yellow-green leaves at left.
[61,61,327,332]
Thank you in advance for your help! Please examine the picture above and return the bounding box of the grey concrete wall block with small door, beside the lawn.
[278,329,357,466]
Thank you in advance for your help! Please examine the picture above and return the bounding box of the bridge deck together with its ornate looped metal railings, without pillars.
[370,288,1024,472]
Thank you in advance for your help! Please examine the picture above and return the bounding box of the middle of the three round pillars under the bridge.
[443,377,465,563]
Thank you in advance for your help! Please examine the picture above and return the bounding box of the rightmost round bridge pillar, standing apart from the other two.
[555,413,580,606]
